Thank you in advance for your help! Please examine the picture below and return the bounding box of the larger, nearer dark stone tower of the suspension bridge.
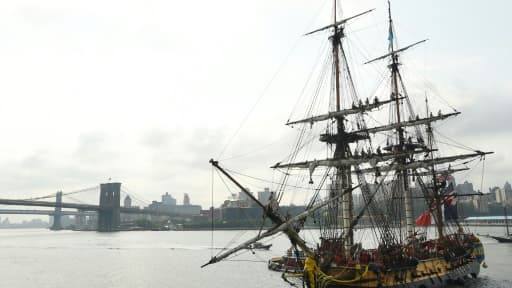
[98,183,121,232]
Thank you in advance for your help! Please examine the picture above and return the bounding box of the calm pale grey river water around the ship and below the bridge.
[0,227,512,288]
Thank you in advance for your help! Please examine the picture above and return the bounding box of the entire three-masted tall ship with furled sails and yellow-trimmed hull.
[204,1,492,288]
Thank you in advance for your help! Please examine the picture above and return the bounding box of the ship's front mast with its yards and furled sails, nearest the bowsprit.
[288,0,372,257]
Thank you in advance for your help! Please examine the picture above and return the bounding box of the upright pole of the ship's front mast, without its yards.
[331,0,353,254]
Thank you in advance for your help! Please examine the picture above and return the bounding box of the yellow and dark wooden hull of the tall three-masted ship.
[304,237,484,288]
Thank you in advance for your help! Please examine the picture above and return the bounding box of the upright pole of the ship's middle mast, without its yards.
[388,0,415,240]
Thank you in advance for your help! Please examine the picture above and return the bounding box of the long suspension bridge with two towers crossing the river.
[0,183,175,232]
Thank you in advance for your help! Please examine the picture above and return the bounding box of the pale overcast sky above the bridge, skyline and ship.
[0,0,512,212]
